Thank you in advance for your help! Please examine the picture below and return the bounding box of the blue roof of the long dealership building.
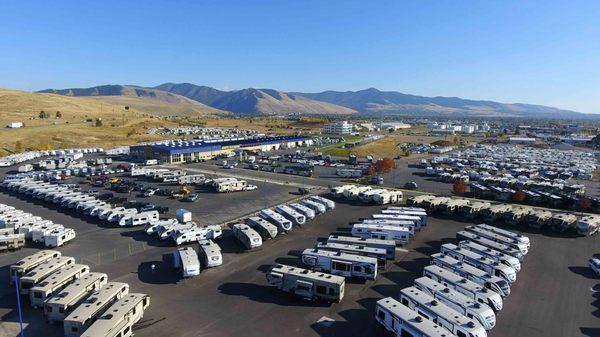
[131,136,310,154]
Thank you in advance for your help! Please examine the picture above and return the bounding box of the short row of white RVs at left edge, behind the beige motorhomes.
[0,204,76,251]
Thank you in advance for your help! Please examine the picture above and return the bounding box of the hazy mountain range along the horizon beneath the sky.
[40,83,595,118]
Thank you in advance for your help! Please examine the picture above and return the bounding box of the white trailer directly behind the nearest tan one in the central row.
[301,249,377,280]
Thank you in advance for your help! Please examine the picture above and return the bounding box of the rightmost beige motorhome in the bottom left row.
[81,293,150,337]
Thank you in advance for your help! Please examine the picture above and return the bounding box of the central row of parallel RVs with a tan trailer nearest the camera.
[266,208,426,302]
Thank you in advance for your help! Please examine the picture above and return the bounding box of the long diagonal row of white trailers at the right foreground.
[375,225,529,337]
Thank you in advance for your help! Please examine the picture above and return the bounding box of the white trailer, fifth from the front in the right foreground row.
[431,253,510,297]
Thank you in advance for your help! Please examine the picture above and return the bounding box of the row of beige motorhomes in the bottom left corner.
[9,250,150,337]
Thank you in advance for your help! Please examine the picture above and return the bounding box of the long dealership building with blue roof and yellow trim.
[130,136,313,164]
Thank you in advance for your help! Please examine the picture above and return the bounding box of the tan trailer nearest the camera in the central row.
[266,264,346,303]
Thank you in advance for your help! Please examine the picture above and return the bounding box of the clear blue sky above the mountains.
[0,0,600,113]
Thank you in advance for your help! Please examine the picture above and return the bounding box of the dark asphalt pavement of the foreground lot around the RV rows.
[0,198,600,337]
